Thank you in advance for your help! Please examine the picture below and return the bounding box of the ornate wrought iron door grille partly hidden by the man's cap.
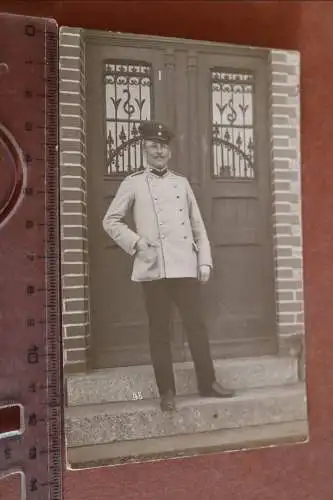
[104,60,153,176]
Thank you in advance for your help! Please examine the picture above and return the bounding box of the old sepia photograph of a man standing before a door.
[59,27,308,468]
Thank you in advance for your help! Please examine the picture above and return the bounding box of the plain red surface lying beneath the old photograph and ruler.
[0,0,333,500]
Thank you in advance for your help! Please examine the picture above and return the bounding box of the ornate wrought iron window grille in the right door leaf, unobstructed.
[211,68,255,179]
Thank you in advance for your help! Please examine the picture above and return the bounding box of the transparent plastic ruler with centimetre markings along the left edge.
[0,14,64,500]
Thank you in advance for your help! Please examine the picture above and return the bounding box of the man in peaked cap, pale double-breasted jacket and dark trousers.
[103,121,233,411]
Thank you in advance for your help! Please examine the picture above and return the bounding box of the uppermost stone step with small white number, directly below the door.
[67,356,298,406]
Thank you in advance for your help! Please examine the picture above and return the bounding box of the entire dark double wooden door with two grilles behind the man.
[87,38,276,368]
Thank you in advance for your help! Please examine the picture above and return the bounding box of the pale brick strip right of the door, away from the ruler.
[270,50,304,372]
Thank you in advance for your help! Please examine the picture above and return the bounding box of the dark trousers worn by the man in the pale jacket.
[142,278,215,394]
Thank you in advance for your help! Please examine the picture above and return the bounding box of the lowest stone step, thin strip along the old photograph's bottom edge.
[67,420,309,470]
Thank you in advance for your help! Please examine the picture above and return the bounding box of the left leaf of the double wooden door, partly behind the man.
[87,43,183,368]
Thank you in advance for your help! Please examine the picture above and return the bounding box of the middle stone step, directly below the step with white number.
[65,383,307,448]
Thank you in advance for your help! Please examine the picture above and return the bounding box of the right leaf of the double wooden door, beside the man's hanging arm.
[189,53,276,358]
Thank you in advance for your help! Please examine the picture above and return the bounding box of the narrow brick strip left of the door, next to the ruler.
[59,28,89,373]
